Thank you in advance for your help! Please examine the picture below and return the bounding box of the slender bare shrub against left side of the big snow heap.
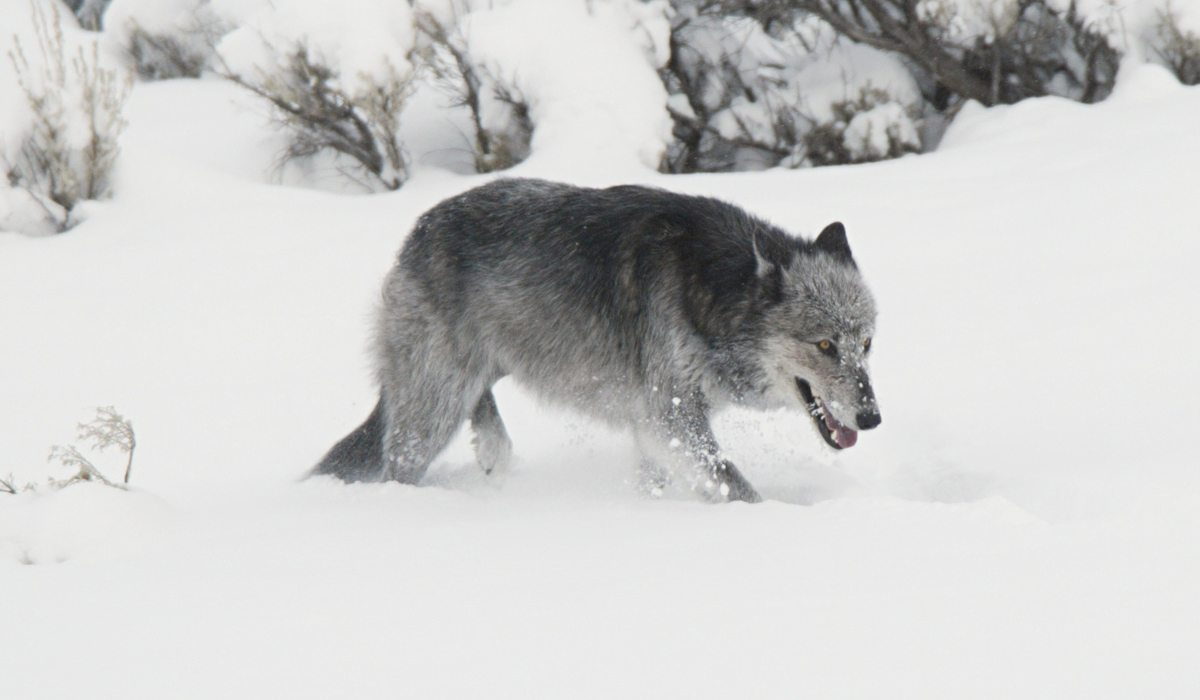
[415,10,533,173]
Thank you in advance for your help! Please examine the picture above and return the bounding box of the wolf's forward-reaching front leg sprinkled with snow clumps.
[637,391,762,503]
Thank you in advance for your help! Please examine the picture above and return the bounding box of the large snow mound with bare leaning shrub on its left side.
[416,0,670,170]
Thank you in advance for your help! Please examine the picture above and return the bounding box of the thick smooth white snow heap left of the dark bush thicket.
[463,0,671,175]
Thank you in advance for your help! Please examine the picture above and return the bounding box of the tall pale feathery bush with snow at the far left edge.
[4,1,130,232]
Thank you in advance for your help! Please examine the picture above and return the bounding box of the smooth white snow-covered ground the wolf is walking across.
[0,10,1200,699]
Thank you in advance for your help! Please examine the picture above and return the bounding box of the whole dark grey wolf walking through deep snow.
[313,180,880,501]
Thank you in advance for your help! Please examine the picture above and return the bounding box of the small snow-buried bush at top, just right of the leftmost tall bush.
[104,0,232,80]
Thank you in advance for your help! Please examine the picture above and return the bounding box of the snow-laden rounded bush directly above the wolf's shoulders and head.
[661,0,920,173]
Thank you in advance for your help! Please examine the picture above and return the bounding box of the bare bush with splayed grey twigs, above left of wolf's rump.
[222,42,413,190]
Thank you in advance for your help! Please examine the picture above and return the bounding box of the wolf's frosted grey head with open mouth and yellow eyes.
[755,223,882,449]
